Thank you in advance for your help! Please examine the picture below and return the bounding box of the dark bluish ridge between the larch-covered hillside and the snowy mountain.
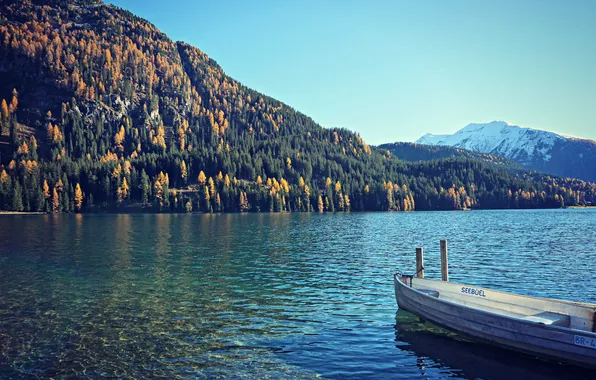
[378,142,524,170]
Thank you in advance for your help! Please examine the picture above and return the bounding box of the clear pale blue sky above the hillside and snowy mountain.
[108,0,596,145]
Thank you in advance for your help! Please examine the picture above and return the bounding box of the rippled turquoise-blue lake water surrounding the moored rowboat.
[0,209,596,378]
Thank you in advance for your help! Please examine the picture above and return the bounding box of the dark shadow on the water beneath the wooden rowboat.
[395,310,594,380]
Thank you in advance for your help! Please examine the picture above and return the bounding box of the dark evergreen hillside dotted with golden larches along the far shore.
[0,0,596,212]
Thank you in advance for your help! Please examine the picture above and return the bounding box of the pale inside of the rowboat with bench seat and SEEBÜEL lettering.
[399,276,596,332]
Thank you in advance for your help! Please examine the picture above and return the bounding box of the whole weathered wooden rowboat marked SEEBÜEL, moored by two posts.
[394,272,596,368]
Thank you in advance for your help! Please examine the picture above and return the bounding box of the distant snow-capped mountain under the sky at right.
[416,121,596,181]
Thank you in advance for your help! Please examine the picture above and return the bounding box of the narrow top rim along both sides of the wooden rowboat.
[393,273,596,338]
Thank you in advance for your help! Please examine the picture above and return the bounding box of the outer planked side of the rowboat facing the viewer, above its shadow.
[394,276,596,368]
